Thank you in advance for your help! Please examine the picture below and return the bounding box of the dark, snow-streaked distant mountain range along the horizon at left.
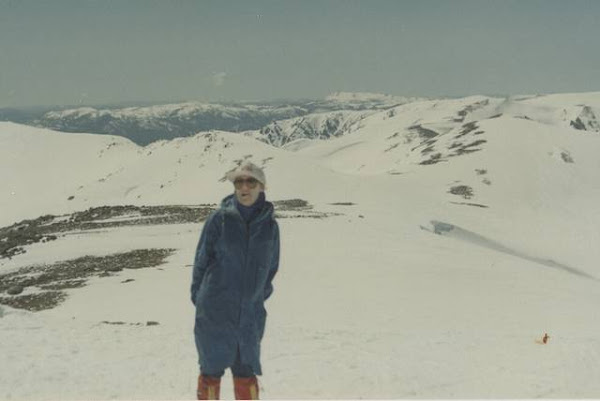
[0,92,417,146]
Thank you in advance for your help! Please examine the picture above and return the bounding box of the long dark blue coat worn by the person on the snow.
[191,195,279,375]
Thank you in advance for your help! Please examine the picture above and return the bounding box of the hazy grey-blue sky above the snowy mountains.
[0,0,600,107]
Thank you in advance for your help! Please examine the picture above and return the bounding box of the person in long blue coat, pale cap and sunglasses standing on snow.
[191,162,279,400]
